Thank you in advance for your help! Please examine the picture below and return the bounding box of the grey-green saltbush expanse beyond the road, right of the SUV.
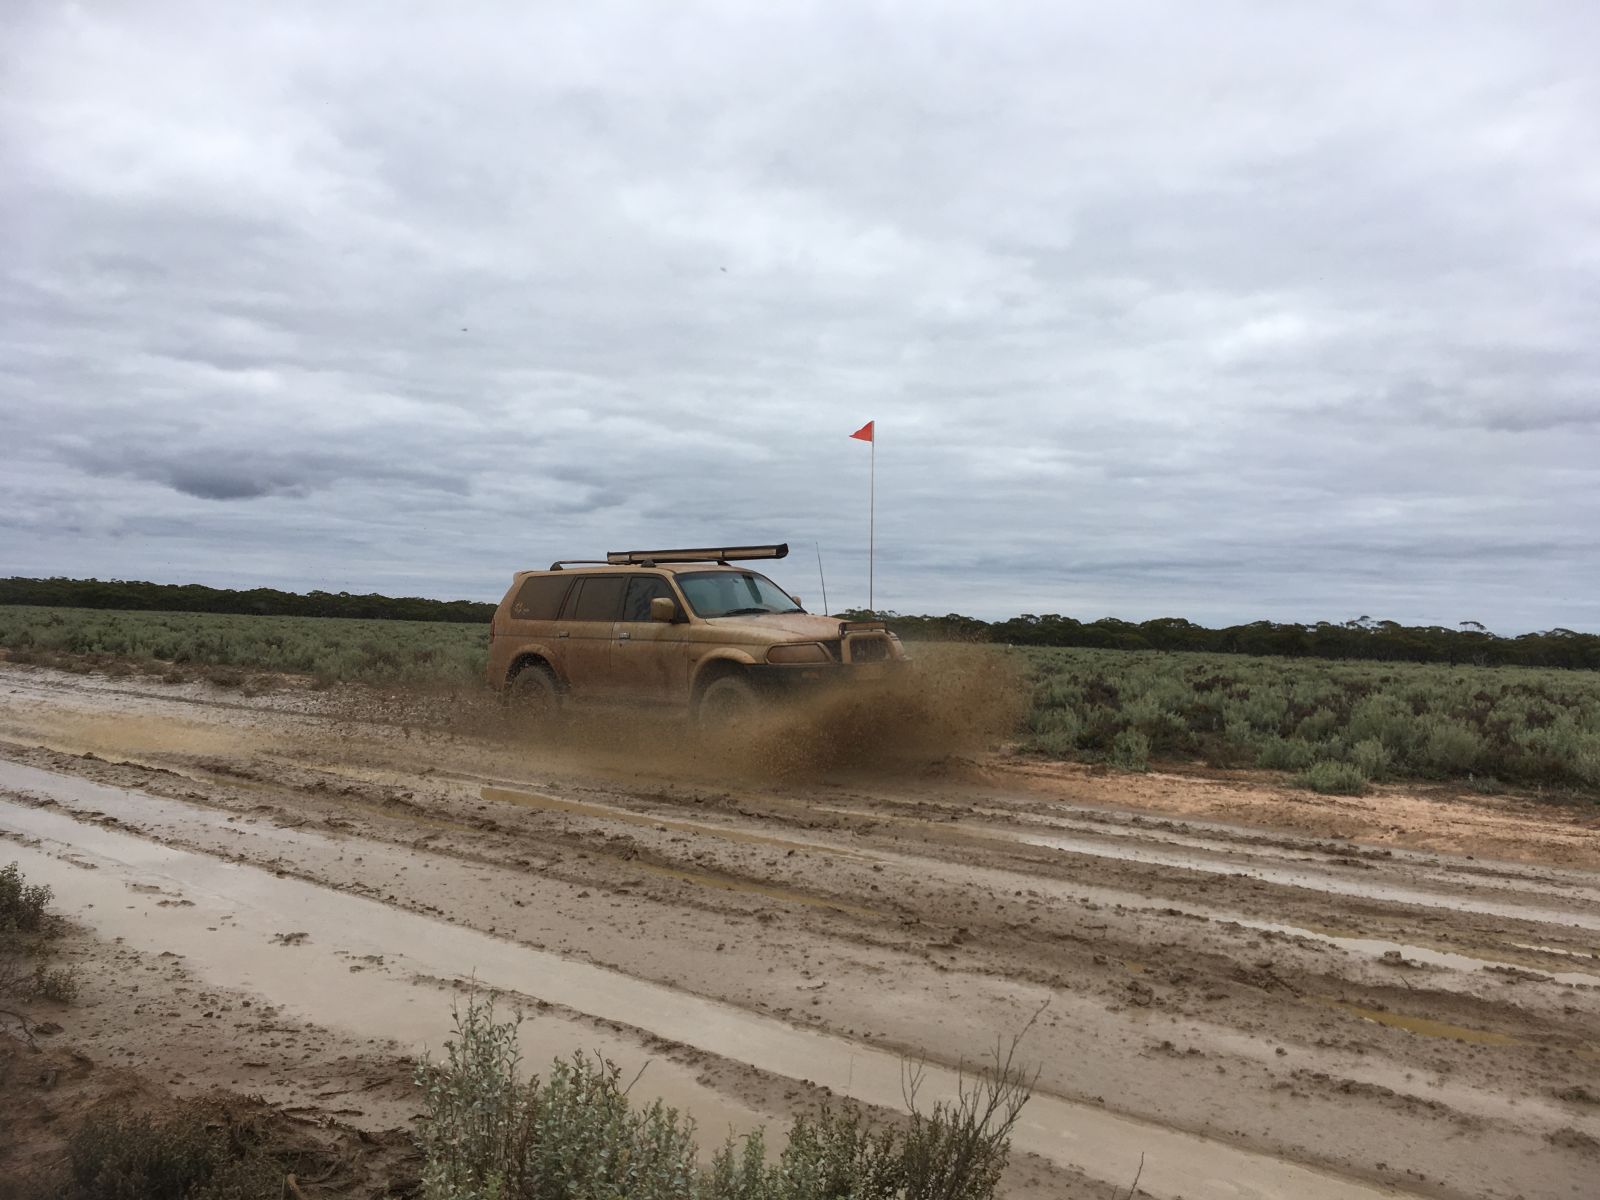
[1011,648,1600,794]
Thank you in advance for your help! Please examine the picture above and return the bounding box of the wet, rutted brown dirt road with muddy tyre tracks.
[0,667,1600,1197]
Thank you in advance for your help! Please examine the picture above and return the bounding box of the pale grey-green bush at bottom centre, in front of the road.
[416,995,1032,1200]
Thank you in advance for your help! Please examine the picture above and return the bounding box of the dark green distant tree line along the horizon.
[0,576,1600,670]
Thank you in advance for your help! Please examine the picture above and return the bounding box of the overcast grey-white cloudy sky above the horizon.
[0,0,1600,632]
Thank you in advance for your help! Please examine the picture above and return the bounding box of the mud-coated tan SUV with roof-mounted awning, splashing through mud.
[488,546,906,725]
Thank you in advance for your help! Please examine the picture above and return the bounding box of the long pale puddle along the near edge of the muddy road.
[0,765,1394,1200]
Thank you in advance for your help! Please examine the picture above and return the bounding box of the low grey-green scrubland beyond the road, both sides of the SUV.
[0,606,1600,795]
